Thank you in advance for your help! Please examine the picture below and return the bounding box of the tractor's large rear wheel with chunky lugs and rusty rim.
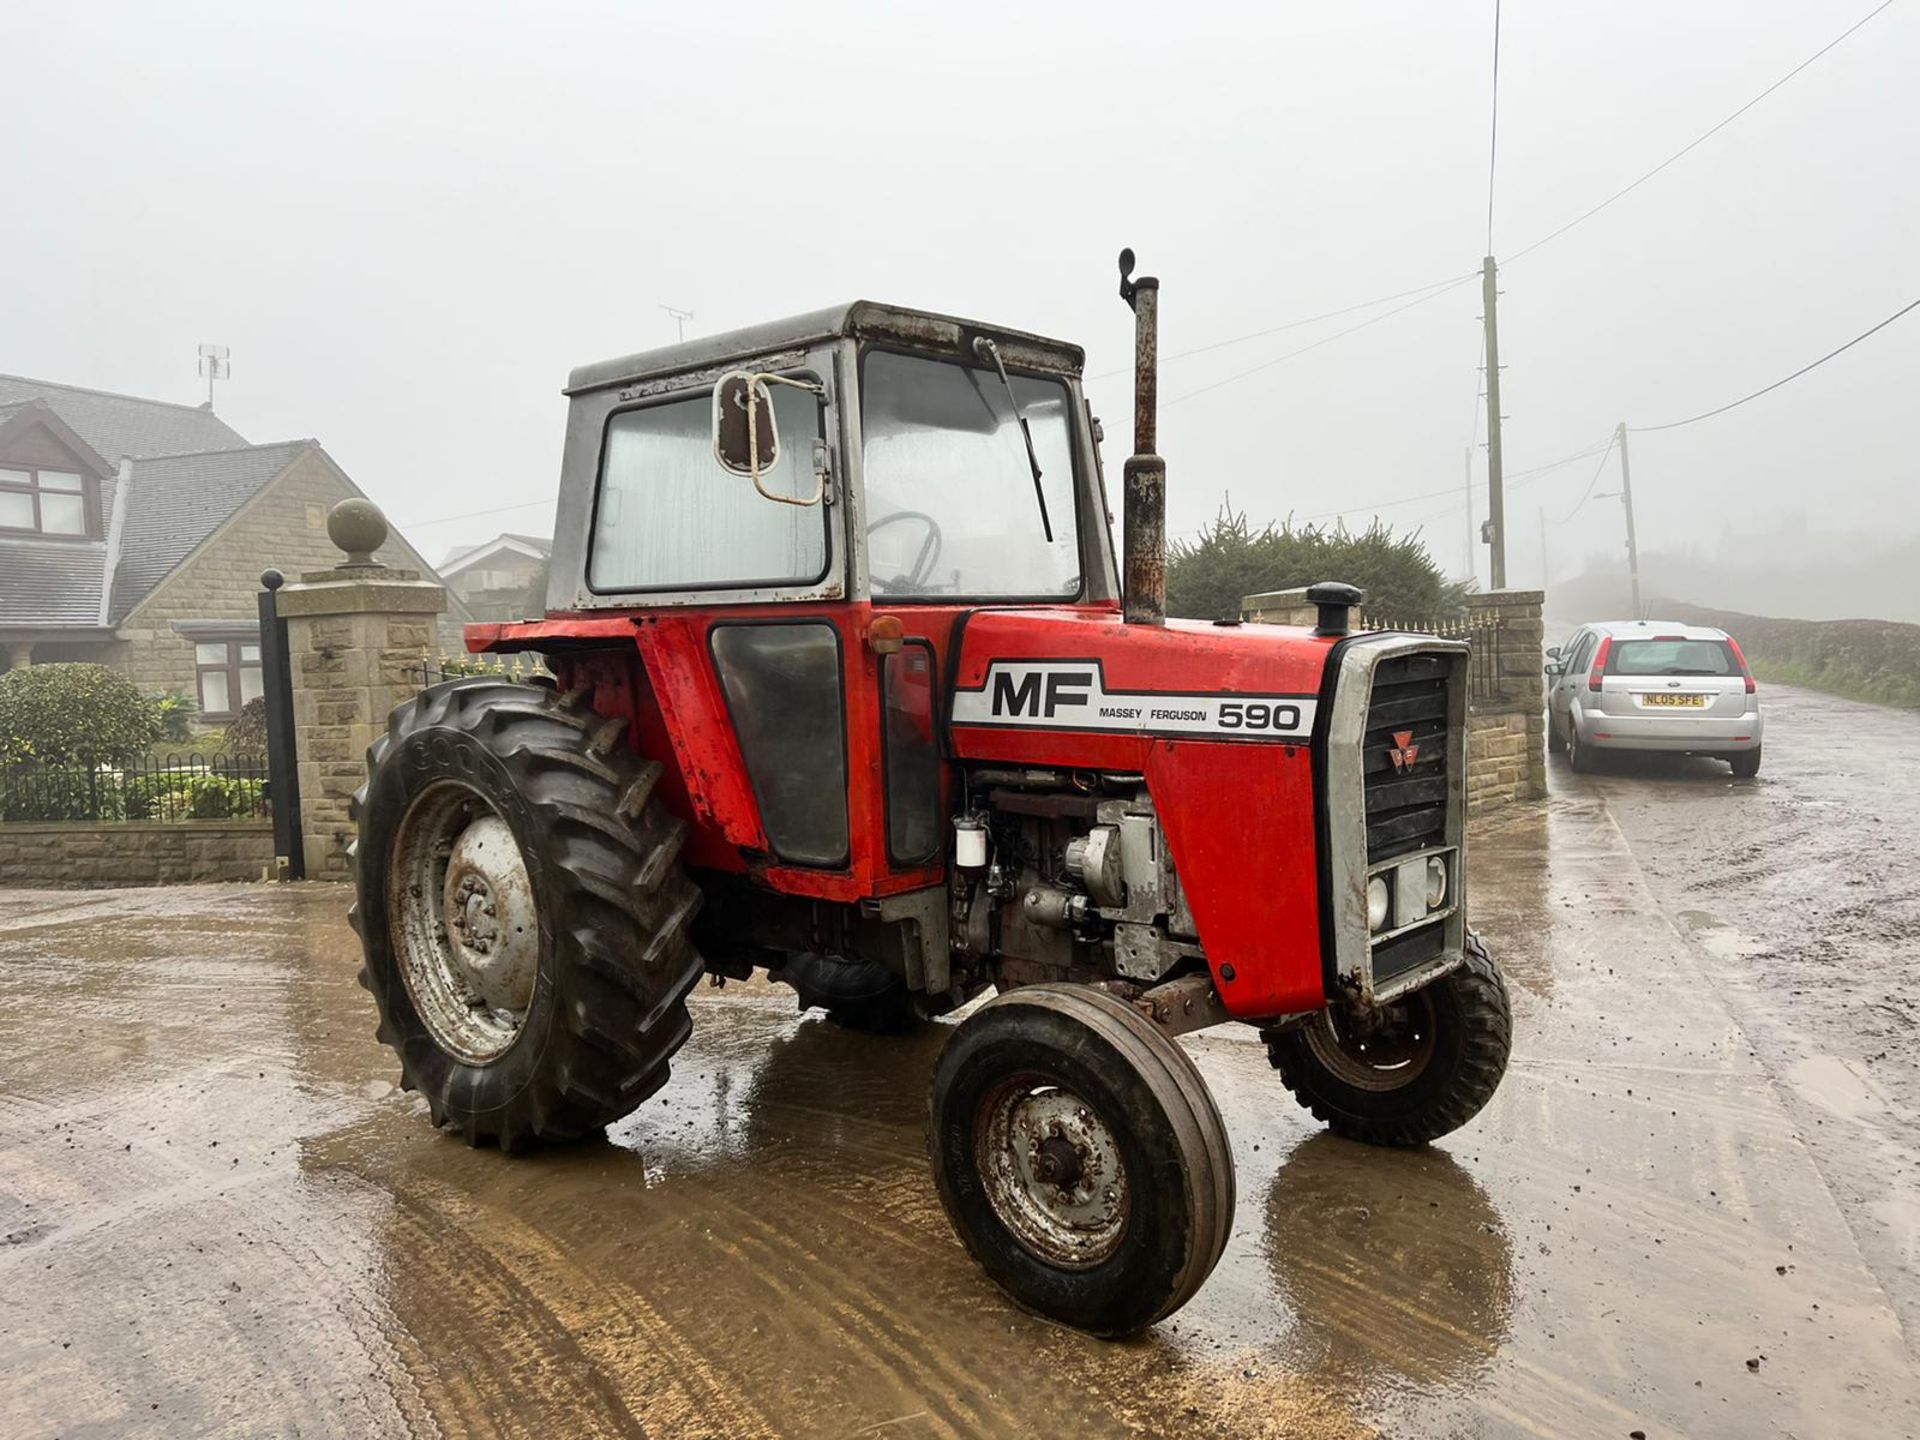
[353,678,703,1150]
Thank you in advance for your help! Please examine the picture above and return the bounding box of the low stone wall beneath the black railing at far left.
[0,820,273,889]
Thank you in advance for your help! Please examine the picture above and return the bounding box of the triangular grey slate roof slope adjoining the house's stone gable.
[108,440,315,624]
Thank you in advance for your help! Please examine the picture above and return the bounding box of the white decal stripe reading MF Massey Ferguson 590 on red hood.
[952,660,1317,739]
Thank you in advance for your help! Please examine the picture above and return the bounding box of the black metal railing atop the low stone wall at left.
[0,751,271,824]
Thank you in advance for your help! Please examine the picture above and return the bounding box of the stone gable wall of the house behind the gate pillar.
[108,447,467,695]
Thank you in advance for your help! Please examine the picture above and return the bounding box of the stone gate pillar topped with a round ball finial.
[278,499,447,879]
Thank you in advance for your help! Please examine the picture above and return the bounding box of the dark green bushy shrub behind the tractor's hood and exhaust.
[1167,511,1467,620]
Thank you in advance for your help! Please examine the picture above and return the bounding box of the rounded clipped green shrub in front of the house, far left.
[0,664,163,768]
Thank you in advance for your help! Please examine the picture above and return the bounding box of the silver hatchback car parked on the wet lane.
[1548,620,1761,778]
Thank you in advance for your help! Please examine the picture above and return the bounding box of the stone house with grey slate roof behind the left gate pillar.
[0,374,468,726]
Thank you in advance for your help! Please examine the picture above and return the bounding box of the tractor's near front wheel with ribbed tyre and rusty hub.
[929,985,1233,1336]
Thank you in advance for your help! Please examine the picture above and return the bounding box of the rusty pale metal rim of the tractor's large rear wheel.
[388,781,540,1066]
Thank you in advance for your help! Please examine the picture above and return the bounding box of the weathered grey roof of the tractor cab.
[564,300,1087,396]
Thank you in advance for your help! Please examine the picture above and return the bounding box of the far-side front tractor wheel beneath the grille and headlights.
[1267,931,1513,1146]
